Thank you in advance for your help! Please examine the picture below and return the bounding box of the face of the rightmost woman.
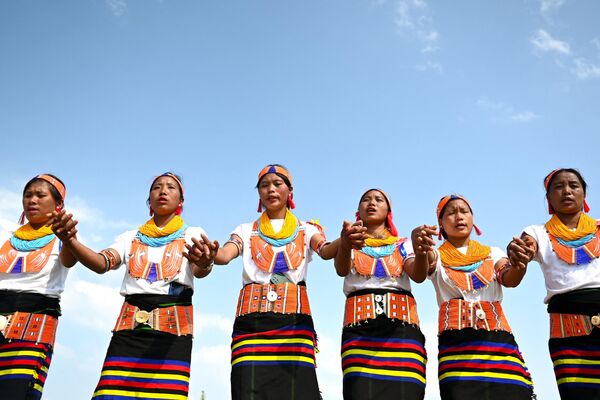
[546,171,585,214]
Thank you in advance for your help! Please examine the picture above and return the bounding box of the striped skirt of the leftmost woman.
[0,335,52,400]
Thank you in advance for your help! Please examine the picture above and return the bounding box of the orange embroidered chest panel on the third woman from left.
[250,222,305,273]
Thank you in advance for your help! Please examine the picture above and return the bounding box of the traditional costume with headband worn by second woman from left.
[93,174,204,400]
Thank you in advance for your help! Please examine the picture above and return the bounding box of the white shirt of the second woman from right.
[428,246,506,306]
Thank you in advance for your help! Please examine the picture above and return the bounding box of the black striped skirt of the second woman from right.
[438,328,533,400]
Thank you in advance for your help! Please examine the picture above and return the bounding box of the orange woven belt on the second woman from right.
[438,299,511,333]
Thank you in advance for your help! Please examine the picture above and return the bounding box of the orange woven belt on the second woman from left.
[113,302,194,336]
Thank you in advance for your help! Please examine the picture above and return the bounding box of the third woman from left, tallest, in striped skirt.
[215,164,336,400]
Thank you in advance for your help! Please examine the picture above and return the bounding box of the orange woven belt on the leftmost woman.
[0,311,58,346]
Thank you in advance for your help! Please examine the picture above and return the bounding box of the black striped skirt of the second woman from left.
[93,329,192,400]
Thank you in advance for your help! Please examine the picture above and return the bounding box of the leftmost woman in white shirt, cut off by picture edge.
[0,174,75,400]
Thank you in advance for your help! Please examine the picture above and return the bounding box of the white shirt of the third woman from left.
[231,219,321,285]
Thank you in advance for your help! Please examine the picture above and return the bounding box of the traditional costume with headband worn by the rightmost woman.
[524,170,600,400]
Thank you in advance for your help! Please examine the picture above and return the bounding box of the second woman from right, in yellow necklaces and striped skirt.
[417,195,533,400]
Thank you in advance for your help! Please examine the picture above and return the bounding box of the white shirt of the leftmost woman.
[0,231,69,298]
